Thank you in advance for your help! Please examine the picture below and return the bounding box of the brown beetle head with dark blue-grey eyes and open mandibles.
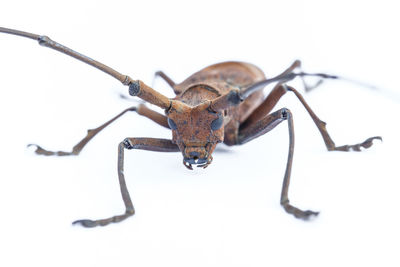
[166,100,224,169]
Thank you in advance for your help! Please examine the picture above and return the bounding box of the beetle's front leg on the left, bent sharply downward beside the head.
[73,138,179,227]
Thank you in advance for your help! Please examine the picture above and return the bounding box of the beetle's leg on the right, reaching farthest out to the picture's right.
[240,84,382,151]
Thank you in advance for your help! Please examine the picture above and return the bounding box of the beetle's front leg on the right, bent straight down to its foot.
[238,108,318,220]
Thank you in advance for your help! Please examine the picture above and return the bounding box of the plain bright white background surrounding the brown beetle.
[0,0,400,267]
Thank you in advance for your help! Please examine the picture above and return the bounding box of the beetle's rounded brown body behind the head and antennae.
[174,61,265,144]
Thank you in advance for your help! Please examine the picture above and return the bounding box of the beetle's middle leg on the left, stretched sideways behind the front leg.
[28,105,169,156]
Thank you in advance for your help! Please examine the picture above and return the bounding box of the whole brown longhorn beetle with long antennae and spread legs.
[0,27,382,227]
